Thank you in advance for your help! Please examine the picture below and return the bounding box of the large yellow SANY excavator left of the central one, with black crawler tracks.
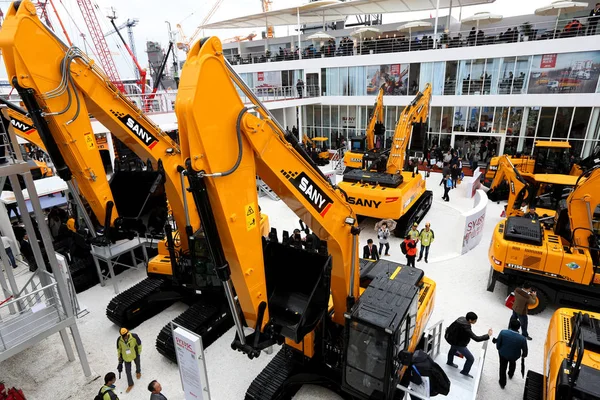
[0,1,268,360]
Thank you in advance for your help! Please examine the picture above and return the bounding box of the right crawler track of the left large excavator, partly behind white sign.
[156,297,233,363]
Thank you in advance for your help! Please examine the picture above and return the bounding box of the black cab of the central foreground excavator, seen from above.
[343,267,424,400]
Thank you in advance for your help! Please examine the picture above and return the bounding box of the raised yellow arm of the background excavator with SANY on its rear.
[387,84,431,174]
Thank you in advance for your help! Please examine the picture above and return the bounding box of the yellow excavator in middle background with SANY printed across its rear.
[339,84,433,237]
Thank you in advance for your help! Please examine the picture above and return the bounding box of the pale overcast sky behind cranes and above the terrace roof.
[0,0,584,79]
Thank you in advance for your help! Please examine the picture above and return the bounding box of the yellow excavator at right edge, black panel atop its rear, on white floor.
[488,166,600,314]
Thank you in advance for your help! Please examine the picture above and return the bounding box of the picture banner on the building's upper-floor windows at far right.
[528,51,600,94]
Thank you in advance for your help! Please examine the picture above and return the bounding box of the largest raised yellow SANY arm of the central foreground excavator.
[175,38,358,328]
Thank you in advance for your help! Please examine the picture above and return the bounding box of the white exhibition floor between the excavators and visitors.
[0,174,553,400]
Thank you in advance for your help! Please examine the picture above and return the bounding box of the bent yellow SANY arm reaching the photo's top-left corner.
[0,0,195,249]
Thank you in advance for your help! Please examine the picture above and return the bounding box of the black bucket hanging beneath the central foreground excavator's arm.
[264,241,331,343]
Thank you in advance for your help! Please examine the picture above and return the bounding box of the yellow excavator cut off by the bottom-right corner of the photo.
[523,308,600,400]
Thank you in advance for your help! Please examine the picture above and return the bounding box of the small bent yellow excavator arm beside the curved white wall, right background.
[490,155,531,216]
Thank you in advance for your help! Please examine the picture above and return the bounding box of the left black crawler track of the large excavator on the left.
[106,278,170,329]
